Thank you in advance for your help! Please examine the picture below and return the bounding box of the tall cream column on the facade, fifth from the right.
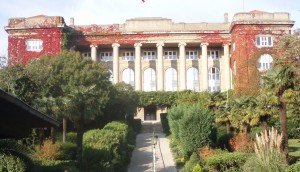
[134,43,142,91]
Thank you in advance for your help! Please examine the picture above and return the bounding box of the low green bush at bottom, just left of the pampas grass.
[205,152,251,171]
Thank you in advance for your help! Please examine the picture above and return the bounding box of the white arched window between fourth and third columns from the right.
[165,68,177,91]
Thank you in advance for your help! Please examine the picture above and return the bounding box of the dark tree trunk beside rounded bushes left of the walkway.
[76,118,83,168]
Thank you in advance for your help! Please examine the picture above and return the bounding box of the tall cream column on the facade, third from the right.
[178,42,186,91]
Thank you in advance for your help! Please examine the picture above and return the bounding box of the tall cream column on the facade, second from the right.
[200,43,208,91]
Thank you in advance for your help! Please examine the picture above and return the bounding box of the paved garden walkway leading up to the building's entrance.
[128,122,177,172]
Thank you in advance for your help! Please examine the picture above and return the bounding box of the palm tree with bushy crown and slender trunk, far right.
[263,66,296,160]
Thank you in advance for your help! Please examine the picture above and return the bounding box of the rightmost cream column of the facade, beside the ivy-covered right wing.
[223,44,231,91]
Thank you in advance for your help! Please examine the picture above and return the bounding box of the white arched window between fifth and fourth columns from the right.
[144,68,156,91]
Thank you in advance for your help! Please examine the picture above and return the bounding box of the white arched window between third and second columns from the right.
[186,67,199,91]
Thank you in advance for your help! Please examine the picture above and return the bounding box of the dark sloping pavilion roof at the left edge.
[0,89,59,139]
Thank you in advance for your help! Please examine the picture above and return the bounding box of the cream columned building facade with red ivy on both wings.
[5,11,294,119]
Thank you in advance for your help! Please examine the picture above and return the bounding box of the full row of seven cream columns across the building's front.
[90,42,230,91]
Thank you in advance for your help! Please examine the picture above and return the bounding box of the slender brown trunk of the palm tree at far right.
[279,95,289,163]
